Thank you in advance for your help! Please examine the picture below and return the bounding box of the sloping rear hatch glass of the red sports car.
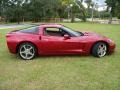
[19,26,39,34]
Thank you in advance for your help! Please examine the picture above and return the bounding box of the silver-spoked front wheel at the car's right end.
[92,42,108,57]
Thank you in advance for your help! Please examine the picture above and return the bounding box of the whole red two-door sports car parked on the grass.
[6,24,115,60]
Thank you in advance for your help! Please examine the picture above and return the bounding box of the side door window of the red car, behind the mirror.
[44,28,62,36]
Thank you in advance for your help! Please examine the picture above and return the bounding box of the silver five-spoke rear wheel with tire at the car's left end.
[18,43,37,60]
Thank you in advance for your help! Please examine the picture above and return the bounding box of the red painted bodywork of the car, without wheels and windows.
[6,24,115,55]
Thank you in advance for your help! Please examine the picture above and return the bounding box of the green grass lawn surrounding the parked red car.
[0,23,120,90]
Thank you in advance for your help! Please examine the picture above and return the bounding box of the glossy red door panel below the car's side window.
[41,26,82,54]
